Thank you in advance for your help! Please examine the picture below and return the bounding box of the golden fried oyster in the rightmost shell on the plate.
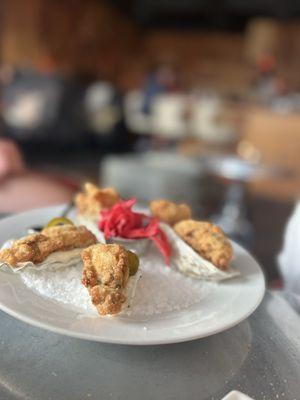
[174,219,233,270]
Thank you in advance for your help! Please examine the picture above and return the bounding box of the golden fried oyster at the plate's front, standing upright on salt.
[81,244,129,315]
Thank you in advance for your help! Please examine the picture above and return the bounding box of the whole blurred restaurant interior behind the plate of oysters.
[0,0,300,287]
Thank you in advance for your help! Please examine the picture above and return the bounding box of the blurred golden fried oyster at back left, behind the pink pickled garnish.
[75,183,120,217]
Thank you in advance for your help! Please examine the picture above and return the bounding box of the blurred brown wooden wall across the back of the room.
[0,0,300,93]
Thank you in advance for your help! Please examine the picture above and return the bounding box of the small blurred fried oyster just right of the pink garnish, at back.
[150,200,191,225]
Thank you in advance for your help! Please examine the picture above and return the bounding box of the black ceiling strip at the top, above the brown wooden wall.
[110,0,300,30]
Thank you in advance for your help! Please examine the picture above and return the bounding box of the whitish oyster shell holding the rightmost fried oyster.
[161,223,240,281]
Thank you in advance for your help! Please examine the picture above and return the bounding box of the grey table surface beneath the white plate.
[0,292,300,400]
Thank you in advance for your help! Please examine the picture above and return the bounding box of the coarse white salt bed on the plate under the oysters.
[20,242,217,318]
